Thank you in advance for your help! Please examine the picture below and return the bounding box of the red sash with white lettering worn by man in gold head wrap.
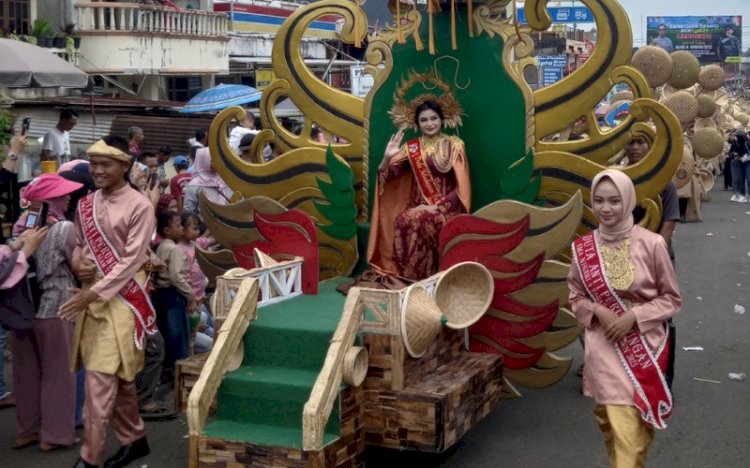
[78,192,156,349]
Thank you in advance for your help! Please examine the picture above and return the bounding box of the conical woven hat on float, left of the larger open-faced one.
[401,284,447,358]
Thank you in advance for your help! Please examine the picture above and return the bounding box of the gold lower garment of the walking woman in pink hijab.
[594,405,654,468]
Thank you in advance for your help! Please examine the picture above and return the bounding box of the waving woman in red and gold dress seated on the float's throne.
[367,100,471,280]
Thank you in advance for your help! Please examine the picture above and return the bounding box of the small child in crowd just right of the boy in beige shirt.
[178,213,214,353]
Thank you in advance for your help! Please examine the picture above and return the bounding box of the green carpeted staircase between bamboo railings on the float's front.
[205,279,347,447]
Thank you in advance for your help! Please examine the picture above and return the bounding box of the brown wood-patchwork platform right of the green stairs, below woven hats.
[364,329,502,453]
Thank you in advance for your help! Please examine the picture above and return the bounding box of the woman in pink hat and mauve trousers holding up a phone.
[13,174,81,451]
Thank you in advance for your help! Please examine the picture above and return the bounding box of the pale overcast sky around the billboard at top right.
[604,0,750,49]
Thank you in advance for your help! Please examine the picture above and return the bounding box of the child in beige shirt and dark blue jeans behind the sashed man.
[155,211,198,381]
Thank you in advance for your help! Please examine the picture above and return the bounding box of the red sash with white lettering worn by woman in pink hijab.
[573,231,672,429]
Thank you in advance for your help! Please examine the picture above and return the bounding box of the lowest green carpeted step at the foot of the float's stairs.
[203,420,338,449]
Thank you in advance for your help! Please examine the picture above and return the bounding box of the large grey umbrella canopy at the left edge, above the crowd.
[0,39,89,88]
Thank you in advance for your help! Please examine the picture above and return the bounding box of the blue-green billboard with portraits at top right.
[646,16,743,63]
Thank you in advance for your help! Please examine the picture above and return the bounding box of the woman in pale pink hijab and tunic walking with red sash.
[568,169,682,467]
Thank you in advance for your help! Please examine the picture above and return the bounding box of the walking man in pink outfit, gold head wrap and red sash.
[58,138,156,468]
